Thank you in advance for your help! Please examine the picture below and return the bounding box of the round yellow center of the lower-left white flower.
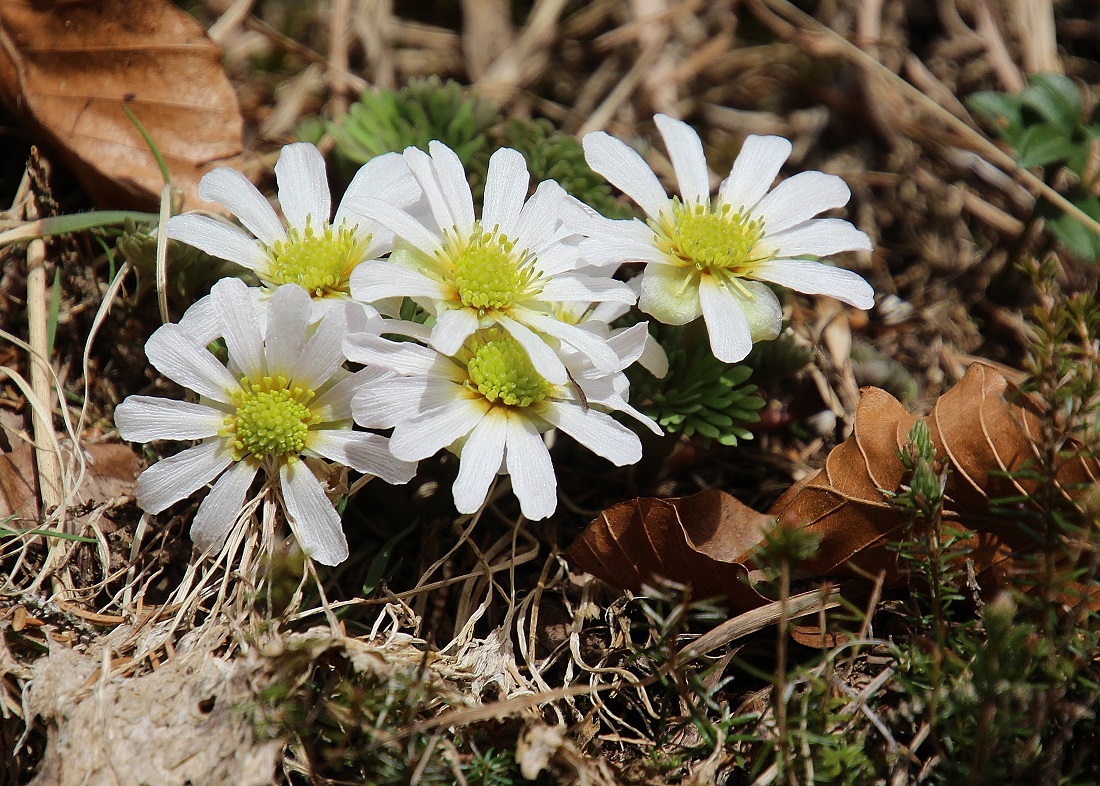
[220,376,319,461]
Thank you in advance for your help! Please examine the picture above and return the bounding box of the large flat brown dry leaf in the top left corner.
[0,0,243,210]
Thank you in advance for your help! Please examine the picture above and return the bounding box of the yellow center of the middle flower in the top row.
[443,224,535,313]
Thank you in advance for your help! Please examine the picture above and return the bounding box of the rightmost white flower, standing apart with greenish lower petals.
[580,114,875,363]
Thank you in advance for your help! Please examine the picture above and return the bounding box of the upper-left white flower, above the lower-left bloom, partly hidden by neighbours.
[167,142,420,343]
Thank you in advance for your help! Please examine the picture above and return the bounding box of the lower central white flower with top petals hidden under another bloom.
[344,325,642,520]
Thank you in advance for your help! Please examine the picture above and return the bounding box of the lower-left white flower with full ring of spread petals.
[114,278,416,565]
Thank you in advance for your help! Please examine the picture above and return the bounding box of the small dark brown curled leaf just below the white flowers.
[565,489,771,610]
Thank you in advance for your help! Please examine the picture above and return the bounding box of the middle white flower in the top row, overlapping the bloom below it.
[345,142,636,385]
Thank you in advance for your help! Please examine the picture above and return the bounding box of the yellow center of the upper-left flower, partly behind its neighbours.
[264,221,371,298]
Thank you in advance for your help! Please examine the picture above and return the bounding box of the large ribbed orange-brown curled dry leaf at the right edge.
[765,364,1098,585]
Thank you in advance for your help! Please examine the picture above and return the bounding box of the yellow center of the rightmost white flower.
[650,199,770,277]
